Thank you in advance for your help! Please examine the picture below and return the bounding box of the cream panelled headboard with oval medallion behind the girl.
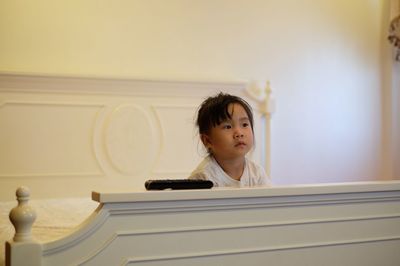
[0,73,269,200]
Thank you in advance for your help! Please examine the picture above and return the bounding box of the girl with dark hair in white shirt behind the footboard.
[189,93,270,187]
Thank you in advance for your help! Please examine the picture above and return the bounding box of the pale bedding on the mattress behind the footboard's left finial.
[0,198,98,265]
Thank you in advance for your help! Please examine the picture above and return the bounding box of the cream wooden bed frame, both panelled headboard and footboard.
[0,73,400,266]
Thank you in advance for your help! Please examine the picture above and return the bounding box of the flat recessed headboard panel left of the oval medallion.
[0,102,103,178]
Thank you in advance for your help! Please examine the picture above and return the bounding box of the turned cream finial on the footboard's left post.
[9,187,36,242]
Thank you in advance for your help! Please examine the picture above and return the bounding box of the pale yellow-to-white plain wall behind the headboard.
[0,0,391,183]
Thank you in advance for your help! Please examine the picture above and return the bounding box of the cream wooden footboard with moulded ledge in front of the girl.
[7,181,400,266]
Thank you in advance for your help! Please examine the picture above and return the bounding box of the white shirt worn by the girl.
[189,156,270,187]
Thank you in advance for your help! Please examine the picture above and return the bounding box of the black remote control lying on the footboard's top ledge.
[144,179,213,190]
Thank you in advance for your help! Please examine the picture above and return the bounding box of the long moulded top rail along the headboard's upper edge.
[0,72,246,98]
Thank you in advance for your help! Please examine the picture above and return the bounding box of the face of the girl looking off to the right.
[201,103,253,160]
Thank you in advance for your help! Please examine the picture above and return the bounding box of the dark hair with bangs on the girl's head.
[196,92,254,134]
